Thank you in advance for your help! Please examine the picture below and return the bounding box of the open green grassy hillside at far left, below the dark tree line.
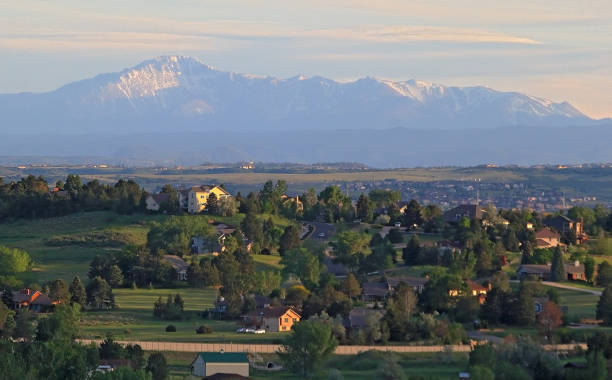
[0,211,164,285]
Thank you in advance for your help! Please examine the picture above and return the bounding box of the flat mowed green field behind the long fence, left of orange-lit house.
[81,288,283,343]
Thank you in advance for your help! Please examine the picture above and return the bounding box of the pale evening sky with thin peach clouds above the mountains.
[0,0,612,118]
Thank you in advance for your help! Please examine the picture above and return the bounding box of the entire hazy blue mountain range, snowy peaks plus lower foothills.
[0,56,612,166]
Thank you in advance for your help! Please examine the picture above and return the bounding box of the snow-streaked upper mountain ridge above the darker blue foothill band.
[0,56,596,132]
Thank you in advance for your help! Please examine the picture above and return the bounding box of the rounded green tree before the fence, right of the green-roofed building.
[278,320,338,378]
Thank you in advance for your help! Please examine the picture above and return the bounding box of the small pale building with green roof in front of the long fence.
[191,350,249,377]
